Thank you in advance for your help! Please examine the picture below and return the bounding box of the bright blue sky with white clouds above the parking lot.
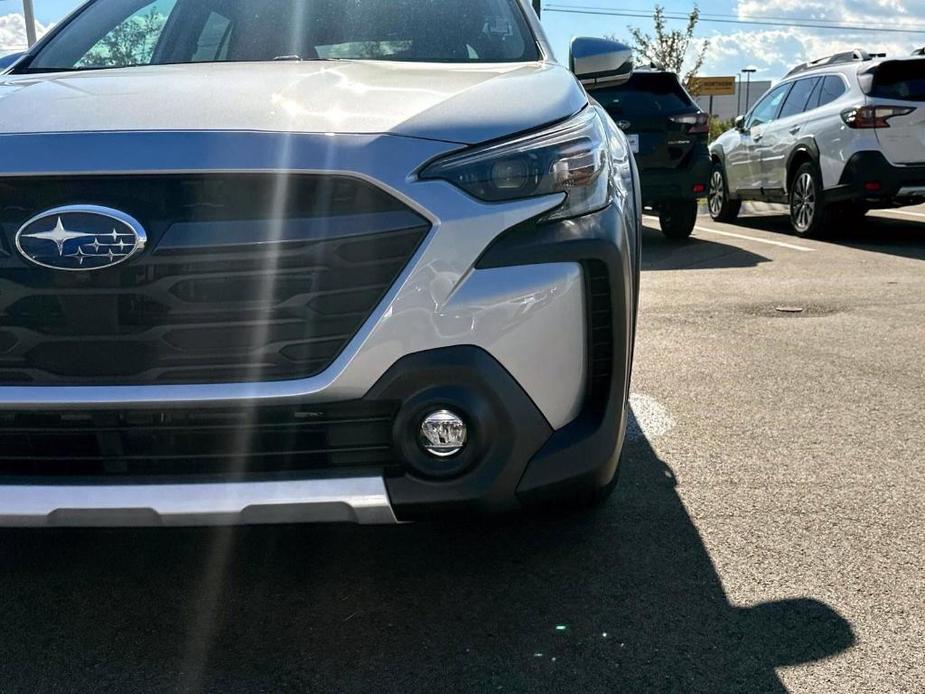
[0,0,925,80]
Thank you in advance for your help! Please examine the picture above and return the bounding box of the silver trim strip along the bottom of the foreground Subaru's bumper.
[0,477,398,527]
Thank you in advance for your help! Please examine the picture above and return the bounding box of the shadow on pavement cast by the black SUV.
[642,227,770,271]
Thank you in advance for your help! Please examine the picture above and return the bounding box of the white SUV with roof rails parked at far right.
[709,50,925,236]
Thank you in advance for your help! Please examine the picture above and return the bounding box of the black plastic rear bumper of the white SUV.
[826,151,925,207]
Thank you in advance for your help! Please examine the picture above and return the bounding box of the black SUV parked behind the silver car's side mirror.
[592,70,710,239]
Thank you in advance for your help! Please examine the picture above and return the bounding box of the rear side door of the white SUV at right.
[761,77,821,196]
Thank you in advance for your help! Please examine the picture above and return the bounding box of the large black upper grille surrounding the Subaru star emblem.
[0,174,429,385]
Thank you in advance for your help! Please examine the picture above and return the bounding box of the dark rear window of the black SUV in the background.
[593,72,698,118]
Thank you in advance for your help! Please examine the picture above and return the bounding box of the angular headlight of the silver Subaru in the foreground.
[421,107,610,219]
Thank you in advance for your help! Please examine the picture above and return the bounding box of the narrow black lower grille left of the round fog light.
[0,402,397,483]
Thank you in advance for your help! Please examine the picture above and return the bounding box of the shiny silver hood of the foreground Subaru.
[0,61,587,144]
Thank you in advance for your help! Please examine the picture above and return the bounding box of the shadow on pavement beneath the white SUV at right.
[736,213,925,260]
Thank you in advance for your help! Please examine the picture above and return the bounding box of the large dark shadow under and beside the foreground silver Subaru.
[0,416,854,692]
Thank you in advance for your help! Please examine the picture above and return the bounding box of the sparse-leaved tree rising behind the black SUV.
[629,5,710,88]
